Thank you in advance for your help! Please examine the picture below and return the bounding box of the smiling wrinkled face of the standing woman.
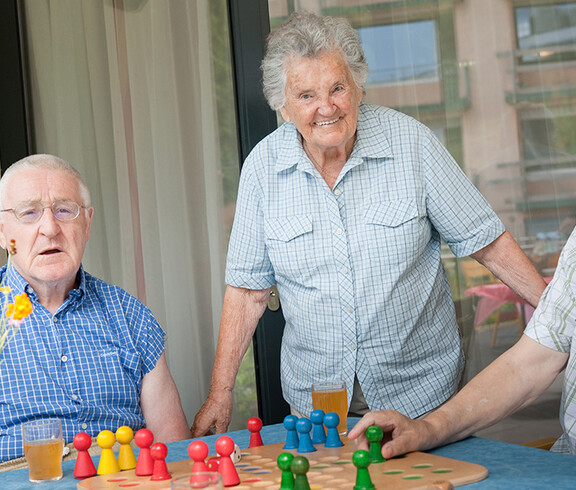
[280,51,362,154]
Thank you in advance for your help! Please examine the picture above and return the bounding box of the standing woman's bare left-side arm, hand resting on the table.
[191,286,270,437]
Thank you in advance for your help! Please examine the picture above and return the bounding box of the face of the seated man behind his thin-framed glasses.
[0,168,94,290]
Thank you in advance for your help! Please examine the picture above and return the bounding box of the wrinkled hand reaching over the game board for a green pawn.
[348,410,433,459]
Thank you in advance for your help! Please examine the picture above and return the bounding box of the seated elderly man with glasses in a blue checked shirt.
[0,155,190,461]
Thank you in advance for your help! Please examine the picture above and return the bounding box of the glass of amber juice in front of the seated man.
[22,419,64,483]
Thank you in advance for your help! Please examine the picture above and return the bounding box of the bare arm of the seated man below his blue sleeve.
[140,352,192,442]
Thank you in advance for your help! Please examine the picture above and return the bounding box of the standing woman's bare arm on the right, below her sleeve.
[470,231,546,307]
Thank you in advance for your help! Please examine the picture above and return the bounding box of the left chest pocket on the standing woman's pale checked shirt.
[264,215,315,282]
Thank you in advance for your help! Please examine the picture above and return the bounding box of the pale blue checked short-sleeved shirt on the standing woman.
[226,104,505,417]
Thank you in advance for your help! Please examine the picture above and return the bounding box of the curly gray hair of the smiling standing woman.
[261,11,368,111]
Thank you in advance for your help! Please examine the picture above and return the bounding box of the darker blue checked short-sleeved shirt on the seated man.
[0,266,164,461]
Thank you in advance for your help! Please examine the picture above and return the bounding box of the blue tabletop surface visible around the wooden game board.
[0,419,576,490]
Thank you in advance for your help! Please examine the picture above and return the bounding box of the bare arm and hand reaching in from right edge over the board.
[348,335,568,458]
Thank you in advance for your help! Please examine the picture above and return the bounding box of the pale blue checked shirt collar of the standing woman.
[276,103,393,173]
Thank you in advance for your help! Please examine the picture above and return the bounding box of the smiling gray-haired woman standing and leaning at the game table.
[192,13,545,436]
